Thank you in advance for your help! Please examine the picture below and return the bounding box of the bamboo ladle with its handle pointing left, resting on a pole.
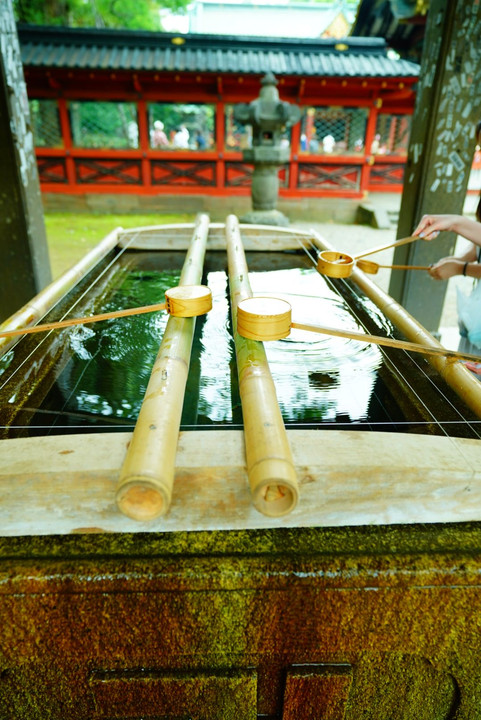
[0,285,212,338]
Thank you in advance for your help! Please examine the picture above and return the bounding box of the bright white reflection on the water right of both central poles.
[250,268,382,423]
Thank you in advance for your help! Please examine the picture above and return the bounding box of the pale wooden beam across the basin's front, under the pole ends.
[0,430,481,536]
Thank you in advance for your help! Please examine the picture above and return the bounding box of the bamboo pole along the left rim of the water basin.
[0,227,122,357]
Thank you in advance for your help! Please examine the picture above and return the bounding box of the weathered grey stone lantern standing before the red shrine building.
[234,72,301,225]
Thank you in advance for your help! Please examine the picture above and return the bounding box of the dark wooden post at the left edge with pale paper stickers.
[0,0,51,321]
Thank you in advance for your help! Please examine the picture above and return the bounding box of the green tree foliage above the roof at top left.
[13,0,188,30]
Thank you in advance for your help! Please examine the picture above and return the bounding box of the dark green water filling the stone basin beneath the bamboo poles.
[0,253,478,437]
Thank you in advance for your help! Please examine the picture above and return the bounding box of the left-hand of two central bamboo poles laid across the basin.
[116,215,209,521]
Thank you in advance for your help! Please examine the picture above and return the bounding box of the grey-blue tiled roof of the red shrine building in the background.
[18,25,419,78]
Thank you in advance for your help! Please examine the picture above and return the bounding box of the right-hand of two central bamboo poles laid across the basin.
[225,215,299,517]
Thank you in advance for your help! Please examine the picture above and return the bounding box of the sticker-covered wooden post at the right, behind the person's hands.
[389,0,481,332]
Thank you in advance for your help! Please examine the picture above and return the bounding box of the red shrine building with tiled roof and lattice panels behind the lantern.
[18,26,419,207]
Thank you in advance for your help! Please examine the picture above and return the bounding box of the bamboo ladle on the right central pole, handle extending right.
[237,297,481,362]
